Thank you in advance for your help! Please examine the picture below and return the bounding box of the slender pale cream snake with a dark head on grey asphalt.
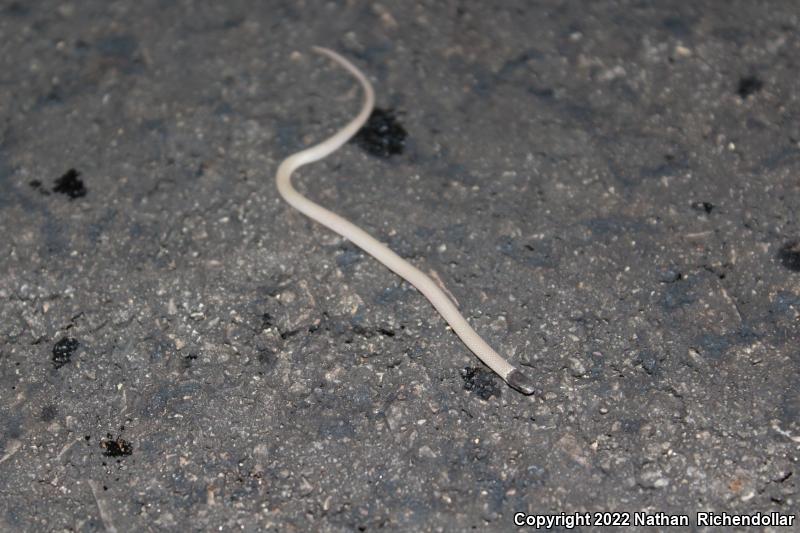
[275,46,535,395]
